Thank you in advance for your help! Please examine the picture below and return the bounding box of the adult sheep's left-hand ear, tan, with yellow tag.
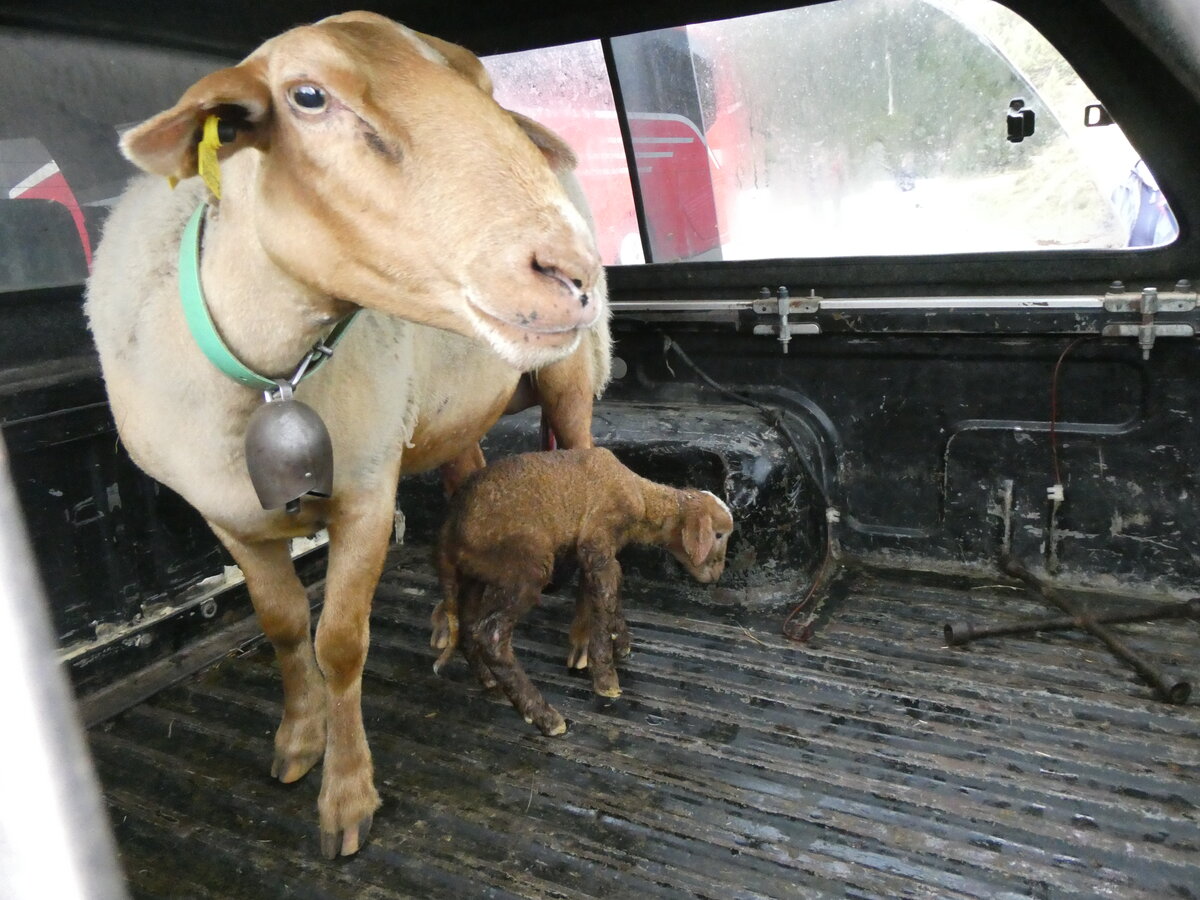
[121,60,271,179]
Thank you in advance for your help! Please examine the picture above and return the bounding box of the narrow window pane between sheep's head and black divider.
[484,41,642,264]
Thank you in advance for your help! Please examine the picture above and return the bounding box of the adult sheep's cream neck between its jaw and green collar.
[200,168,353,378]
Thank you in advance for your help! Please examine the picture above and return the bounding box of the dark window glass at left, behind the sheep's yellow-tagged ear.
[0,29,229,292]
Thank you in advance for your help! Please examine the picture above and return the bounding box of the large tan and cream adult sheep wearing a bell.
[86,12,608,857]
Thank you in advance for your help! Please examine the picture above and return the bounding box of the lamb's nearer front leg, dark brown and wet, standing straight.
[571,545,629,697]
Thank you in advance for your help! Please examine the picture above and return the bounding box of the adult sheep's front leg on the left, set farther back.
[212,526,325,784]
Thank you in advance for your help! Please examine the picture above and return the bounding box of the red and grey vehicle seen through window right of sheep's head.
[487,29,745,264]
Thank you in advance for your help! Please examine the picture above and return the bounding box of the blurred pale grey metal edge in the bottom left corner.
[0,434,127,900]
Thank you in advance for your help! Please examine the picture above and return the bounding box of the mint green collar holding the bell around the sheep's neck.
[179,203,358,391]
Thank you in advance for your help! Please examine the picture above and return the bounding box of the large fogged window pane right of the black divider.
[604,0,1177,262]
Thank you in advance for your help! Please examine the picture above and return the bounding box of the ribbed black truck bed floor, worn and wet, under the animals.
[90,546,1200,899]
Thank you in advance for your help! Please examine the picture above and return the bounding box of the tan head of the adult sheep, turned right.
[122,12,604,368]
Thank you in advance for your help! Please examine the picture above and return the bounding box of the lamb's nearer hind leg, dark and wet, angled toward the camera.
[472,584,566,736]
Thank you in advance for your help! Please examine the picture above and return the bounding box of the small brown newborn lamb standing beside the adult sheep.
[431,448,733,736]
